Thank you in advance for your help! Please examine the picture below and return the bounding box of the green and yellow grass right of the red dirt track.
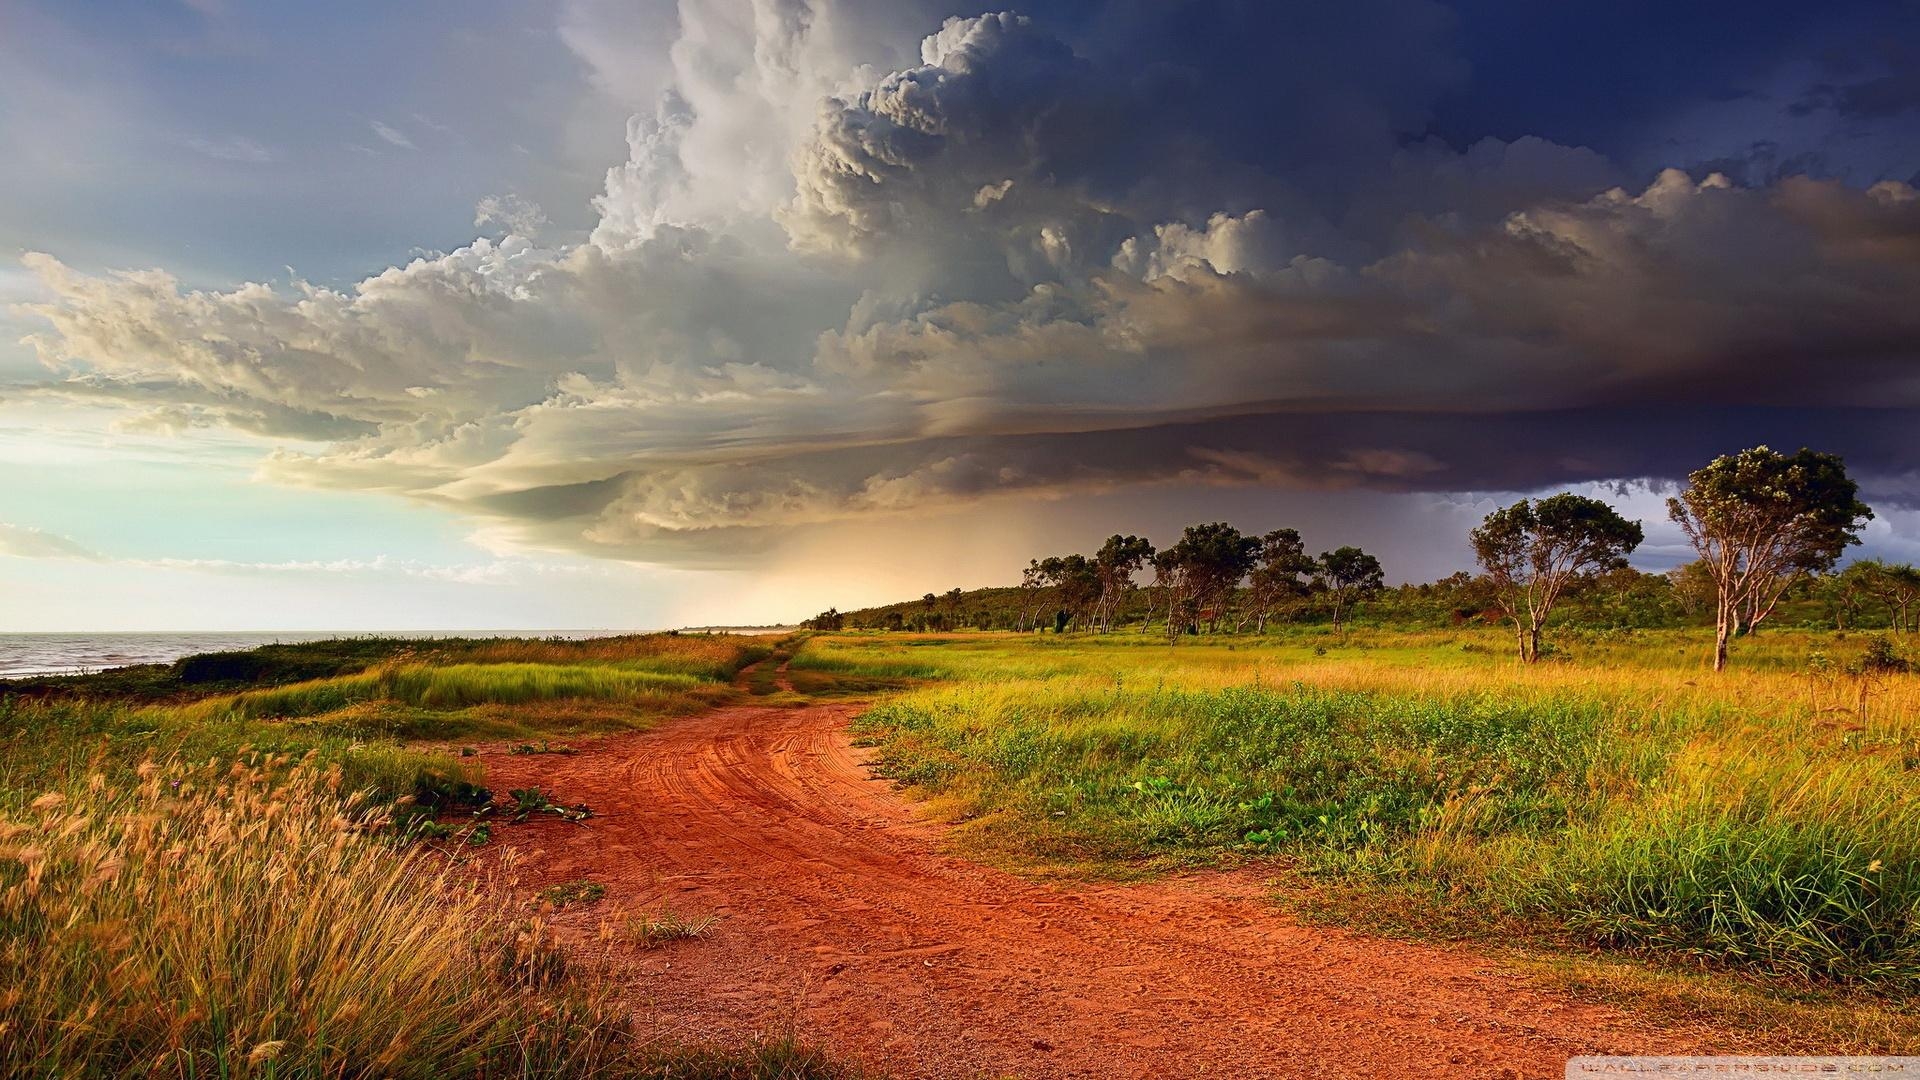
[833,632,1920,997]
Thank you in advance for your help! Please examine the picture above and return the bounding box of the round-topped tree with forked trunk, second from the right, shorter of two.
[1469,492,1645,663]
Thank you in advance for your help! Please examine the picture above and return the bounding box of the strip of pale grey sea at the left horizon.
[0,630,632,678]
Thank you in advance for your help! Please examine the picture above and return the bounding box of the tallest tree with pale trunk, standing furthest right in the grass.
[1667,446,1874,671]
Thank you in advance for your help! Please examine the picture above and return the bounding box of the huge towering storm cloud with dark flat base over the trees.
[15,0,1920,565]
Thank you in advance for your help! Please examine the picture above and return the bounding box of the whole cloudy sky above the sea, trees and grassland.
[0,0,1920,630]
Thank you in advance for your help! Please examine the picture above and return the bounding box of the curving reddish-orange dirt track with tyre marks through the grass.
[486,676,1712,1078]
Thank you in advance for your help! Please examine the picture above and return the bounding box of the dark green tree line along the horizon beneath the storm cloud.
[806,446,1873,671]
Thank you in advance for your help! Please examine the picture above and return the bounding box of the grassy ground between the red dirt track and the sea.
[0,634,845,1080]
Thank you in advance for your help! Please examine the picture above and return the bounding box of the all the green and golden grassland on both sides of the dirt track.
[15,628,1920,1078]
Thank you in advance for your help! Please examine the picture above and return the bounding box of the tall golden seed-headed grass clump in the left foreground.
[0,759,856,1080]
